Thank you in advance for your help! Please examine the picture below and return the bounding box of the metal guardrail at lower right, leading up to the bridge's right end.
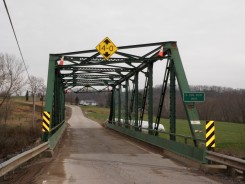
[206,151,245,180]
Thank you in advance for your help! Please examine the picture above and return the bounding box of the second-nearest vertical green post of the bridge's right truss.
[148,63,153,134]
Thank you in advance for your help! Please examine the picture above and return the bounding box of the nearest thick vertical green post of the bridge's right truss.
[170,60,176,141]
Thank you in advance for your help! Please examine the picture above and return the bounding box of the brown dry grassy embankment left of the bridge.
[0,97,42,159]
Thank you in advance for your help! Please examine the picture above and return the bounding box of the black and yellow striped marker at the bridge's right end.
[206,121,215,150]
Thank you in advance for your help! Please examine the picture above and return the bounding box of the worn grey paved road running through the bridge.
[35,106,217,184]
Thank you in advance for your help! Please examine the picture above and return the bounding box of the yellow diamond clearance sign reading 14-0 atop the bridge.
[96,37,117,60]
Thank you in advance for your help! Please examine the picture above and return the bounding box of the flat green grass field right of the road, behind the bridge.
[81,106,245,157]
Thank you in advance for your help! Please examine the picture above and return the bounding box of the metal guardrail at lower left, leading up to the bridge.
[0,142,49,177]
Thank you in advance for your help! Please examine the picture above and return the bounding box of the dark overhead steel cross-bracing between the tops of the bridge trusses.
[53,42,170,91]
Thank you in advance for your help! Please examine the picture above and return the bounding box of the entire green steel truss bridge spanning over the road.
[43,41,206,162]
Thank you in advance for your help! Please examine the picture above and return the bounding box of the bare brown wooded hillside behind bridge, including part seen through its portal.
[66,85,245,123]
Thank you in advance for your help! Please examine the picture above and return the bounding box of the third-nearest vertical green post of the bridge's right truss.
[134,72,139,131]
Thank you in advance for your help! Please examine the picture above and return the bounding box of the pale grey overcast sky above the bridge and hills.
[0,0,245,89]
